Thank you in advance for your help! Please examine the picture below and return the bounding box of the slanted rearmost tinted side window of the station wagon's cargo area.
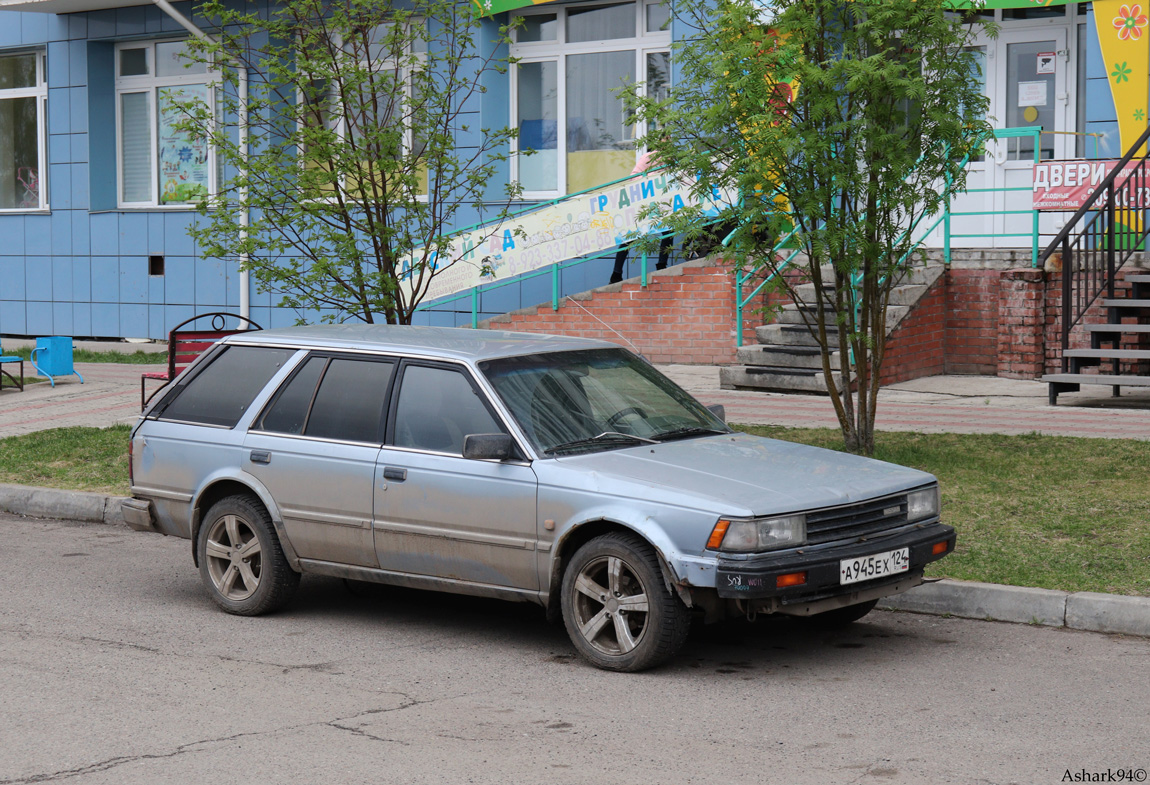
[160,346,296,428]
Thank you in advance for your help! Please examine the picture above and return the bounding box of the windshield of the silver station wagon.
[480,349,729,455]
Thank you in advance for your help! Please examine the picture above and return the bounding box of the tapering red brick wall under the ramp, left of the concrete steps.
[480,260,757,364]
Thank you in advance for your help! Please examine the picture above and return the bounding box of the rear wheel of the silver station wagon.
[196,494,299,616]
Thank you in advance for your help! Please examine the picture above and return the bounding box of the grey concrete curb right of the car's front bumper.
[879,578,1150,637]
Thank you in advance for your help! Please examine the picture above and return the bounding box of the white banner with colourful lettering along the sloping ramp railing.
[414,171,729,302]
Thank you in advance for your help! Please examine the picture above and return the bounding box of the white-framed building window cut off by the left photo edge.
[0,52,48,211]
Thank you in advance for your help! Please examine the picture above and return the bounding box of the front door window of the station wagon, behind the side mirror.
[394,365,507,455]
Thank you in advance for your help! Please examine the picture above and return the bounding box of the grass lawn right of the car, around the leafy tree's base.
[738,425,1150,597]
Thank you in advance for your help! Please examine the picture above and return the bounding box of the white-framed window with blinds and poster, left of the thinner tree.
[116,41,215,207]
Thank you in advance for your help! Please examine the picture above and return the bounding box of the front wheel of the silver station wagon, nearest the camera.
[560,532,691,672]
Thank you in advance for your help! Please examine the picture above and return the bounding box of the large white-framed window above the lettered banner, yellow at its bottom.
[512,2,670,198]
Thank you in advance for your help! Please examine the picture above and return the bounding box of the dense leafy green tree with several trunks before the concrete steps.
[631,0,989,453]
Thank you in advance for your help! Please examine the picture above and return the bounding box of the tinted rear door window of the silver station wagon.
[296,357,394,444]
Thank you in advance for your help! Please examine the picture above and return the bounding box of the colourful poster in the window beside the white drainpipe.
[159,85,208,205]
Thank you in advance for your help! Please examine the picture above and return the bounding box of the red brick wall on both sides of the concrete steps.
[481,260,1147,384]
